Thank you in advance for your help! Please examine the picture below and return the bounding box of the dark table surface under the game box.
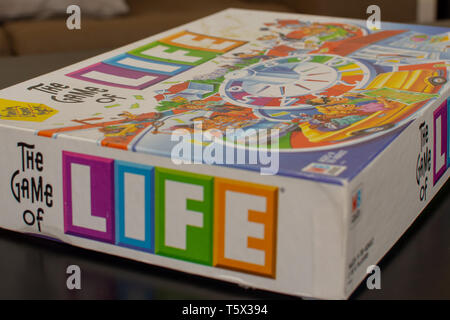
[0,50,450,299]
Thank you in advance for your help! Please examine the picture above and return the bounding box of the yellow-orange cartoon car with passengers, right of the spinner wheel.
[299,62,447,142]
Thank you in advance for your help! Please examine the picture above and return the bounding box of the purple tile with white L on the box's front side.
[62,151,114,243]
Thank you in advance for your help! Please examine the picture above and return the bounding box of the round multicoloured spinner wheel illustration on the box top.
[220,54,370,108]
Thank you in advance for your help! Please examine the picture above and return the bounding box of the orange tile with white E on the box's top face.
[161,31,247,53]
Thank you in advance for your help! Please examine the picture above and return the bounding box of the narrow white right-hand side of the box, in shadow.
[346,92,450,295]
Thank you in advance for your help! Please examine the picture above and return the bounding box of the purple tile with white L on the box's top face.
[66,62,169,90]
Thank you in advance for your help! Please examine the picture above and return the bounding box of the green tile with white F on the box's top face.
[128,41,218,66]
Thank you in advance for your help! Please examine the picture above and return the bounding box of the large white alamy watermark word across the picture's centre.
[171,122,280,175]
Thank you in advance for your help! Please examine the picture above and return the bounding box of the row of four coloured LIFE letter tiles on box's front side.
[62,151,278,278]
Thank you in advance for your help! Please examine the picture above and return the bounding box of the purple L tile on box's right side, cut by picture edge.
[433,99,450,185]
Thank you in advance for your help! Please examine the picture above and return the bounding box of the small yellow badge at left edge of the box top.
[0,99,58,122]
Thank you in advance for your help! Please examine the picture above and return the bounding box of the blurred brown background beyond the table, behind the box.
[0,0,450,57]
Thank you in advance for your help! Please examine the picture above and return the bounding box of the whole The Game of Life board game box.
[0,9,450,299]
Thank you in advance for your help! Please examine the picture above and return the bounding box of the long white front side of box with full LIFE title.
[0,126,345,298]
